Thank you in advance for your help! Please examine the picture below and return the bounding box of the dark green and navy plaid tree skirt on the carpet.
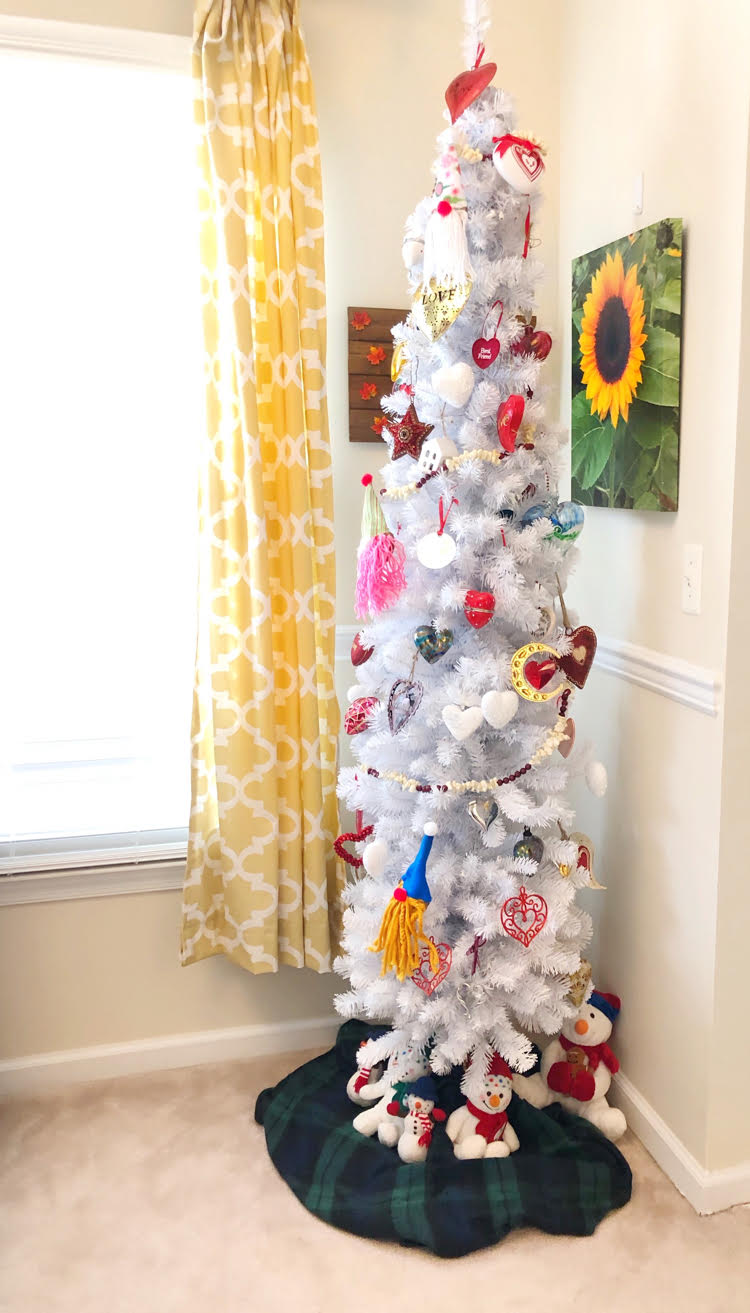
[255,1022,632,1258]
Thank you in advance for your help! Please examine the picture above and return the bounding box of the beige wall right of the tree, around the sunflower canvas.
[560,0,750,1166]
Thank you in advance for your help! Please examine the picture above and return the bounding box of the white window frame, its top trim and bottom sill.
[0,14,192,907]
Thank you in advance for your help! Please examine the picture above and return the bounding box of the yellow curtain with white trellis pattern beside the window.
[183,0,339,972]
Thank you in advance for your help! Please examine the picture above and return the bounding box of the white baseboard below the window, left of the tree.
[0,1016,342,1095]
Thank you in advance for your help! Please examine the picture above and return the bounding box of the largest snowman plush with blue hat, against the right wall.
[514,990,627,1140]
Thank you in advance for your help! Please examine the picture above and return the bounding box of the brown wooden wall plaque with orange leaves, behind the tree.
[347,306,408,442]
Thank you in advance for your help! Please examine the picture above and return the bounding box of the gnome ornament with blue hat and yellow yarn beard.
[370,821,440,981]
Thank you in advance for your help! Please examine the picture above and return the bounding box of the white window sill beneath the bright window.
[0,861,185,907]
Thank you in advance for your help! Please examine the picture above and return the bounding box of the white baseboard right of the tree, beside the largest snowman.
[609,1071,750,1213]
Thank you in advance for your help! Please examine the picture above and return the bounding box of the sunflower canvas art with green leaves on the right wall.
[570,219,683,511]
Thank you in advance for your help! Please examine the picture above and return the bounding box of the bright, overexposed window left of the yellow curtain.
[0,29,202,873]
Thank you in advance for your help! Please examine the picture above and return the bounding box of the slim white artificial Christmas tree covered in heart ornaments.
[336,4,606,1092]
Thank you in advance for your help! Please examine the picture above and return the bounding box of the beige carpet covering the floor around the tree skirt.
[0,1054,750,1313]
